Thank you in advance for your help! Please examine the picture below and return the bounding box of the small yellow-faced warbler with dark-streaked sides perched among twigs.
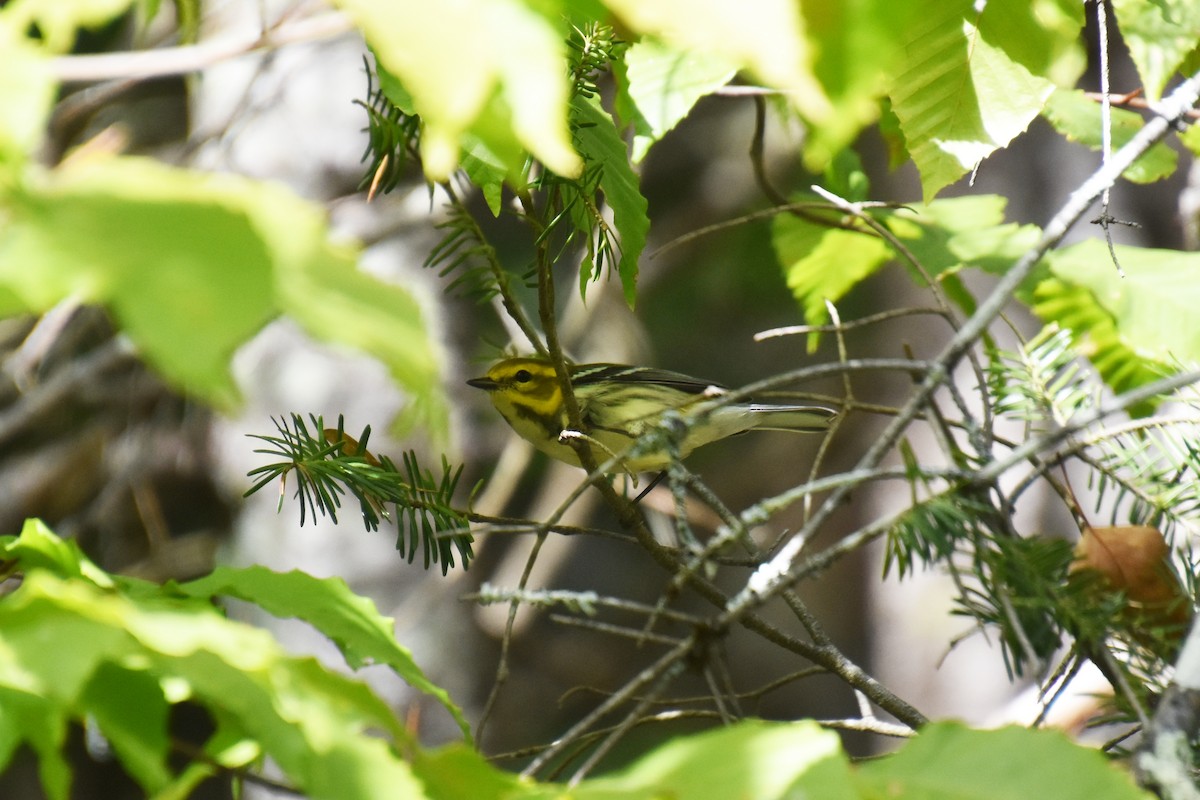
[467,357,836,473]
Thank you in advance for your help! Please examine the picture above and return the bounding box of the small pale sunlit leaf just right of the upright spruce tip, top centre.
[623,38,737,164]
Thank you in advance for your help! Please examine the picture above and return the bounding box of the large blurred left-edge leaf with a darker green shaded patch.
[0,158,276,407]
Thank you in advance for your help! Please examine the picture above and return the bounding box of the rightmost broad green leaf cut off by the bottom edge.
[856,722,1152,800]
